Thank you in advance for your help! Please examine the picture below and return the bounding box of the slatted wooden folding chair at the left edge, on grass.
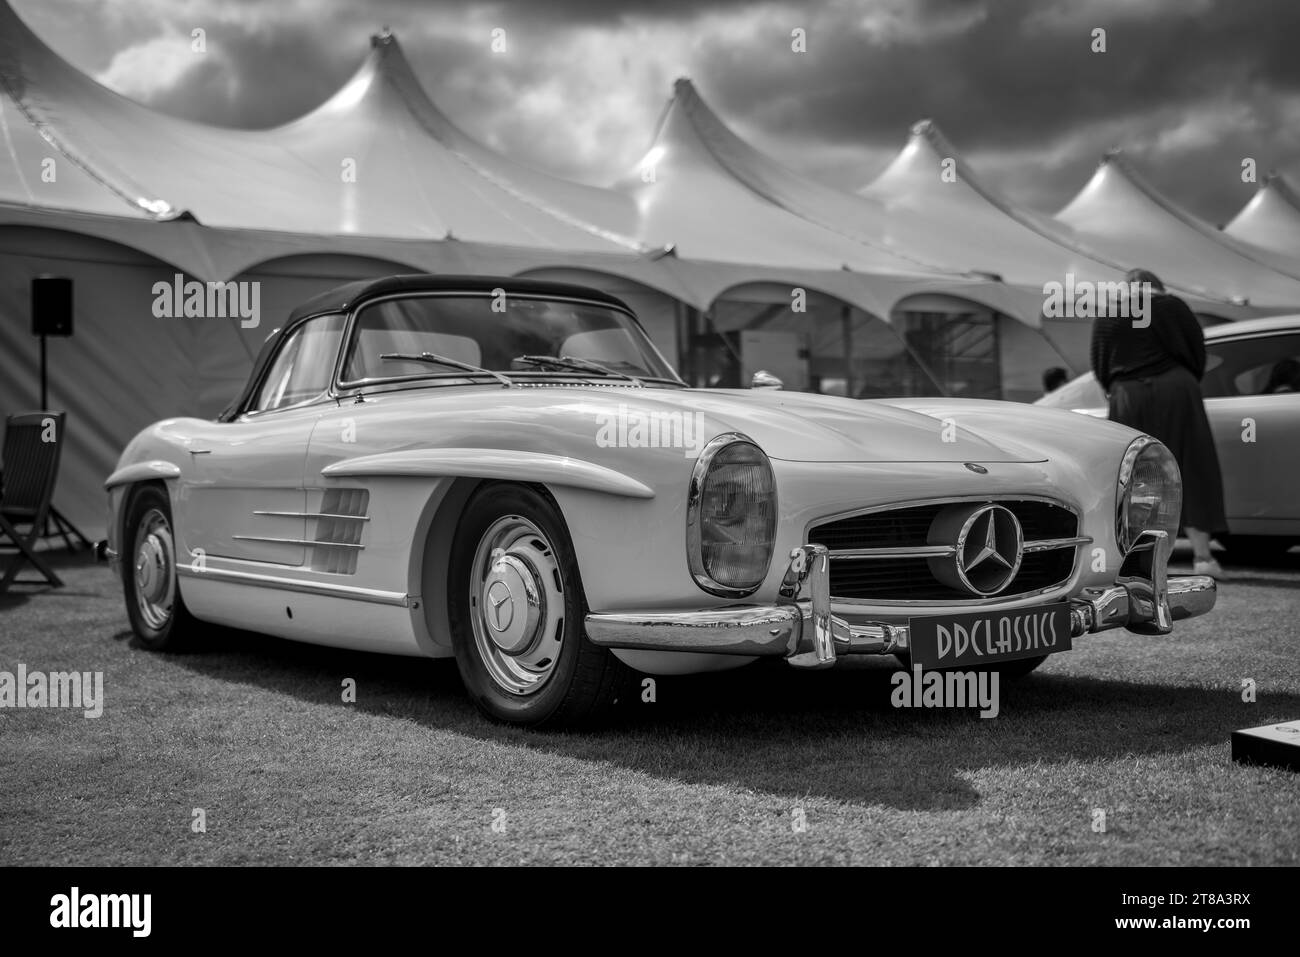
[0,412,65,594]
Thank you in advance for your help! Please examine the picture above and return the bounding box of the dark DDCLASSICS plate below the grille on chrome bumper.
[909,602,1071,668]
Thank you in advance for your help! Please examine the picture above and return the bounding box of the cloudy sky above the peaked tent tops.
[12,0,1300,222]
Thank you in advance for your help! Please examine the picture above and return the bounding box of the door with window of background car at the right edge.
[1201,330,1300,534]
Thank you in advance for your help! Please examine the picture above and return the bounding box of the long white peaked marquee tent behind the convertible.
[0,0,1300,531]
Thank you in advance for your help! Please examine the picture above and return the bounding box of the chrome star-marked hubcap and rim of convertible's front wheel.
[469,515,564,694]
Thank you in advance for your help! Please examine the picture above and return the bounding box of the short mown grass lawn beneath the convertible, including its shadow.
[0,546,1300,865]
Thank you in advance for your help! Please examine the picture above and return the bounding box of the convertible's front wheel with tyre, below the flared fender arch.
[447,484,629,726]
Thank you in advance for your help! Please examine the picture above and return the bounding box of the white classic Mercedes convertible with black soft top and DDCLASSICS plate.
[107,276,1216,724]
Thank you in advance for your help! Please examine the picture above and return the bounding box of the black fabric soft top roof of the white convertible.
[217,273,632,421]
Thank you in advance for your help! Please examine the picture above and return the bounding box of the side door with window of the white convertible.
[181,315,343,566]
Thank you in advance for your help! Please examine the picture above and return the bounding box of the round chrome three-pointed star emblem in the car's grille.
[927,502,1024,598]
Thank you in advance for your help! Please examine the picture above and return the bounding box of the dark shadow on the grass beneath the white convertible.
[152,632,1300,810]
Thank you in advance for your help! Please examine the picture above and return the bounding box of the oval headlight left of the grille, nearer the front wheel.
[686,432,776,598]
